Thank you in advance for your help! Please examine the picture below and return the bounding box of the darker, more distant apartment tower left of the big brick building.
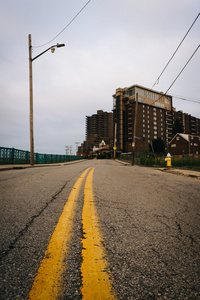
[78,110,113,154]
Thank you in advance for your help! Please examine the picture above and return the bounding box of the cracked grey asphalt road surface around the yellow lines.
[0,160,200,300]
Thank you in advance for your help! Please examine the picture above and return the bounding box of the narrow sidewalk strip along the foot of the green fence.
[0,159,85,171]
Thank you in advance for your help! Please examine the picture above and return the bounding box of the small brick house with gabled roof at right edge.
[168,133,200,155]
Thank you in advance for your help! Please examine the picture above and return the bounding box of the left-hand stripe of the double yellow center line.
[28,168,90,300]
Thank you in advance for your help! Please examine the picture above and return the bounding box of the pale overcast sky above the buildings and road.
[0,0,200,154]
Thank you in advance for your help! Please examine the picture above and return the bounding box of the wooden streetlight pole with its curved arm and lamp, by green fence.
[28,34,65,166]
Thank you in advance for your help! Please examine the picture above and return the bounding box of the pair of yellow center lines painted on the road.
[28,168,116,300]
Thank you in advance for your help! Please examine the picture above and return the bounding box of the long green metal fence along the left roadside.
[0,147,85,165]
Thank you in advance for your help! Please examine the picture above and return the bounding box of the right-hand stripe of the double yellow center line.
[81,168,116,300]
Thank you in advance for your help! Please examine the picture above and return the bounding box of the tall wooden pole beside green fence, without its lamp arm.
[29,34,34,166]
